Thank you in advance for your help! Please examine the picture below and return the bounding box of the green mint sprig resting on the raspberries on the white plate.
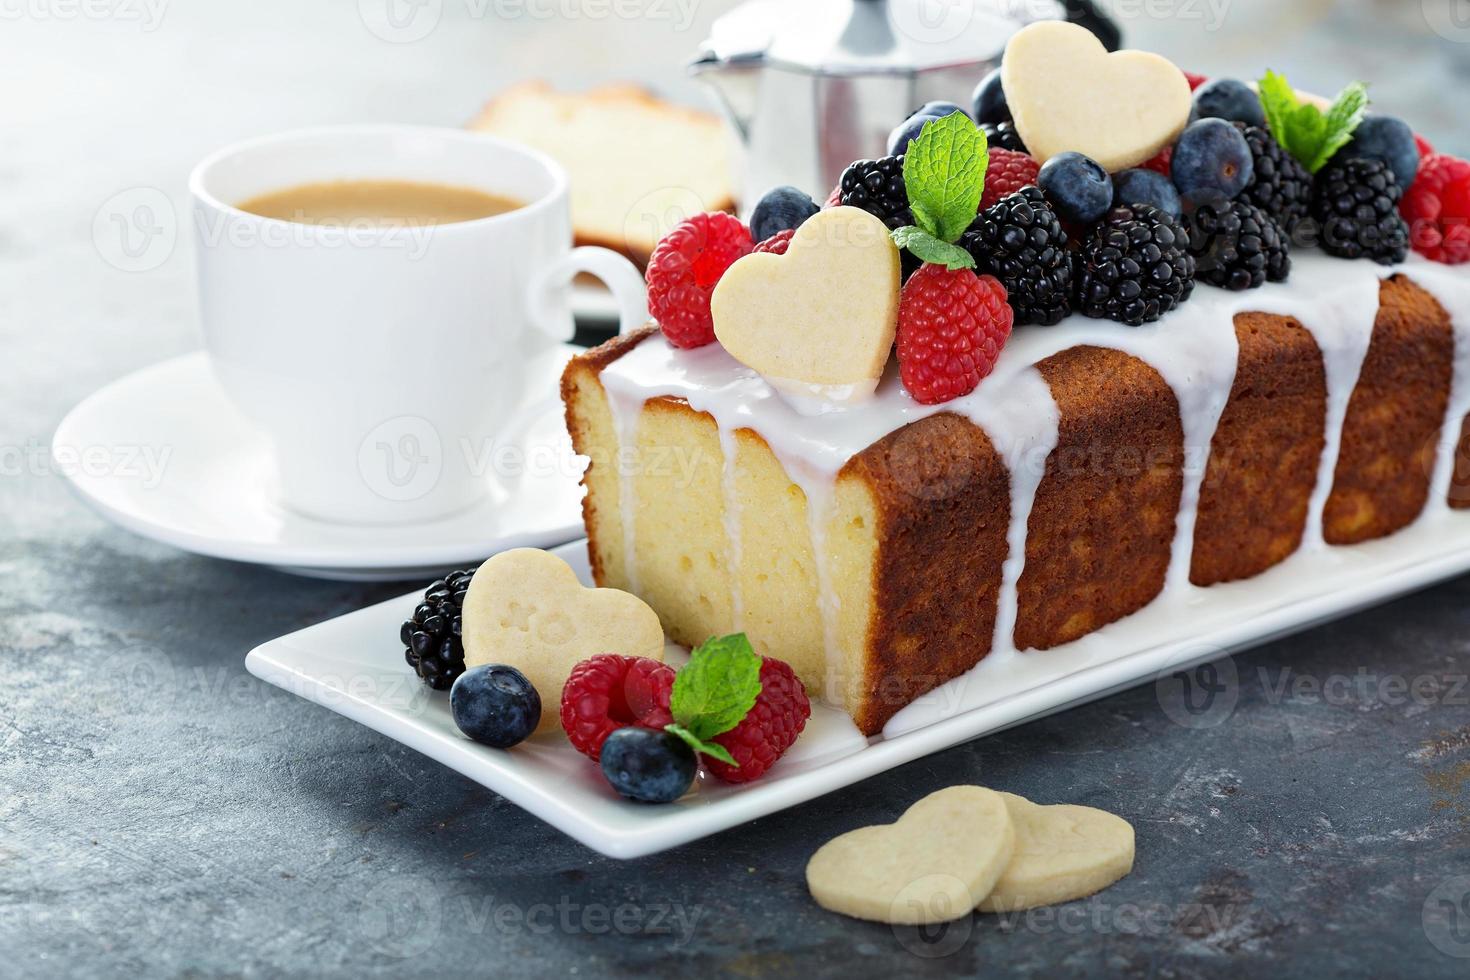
[663,633,760,767]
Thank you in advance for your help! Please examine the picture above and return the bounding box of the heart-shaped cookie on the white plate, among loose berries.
[462,548,663,732]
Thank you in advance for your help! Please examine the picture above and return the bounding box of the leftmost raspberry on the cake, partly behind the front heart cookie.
[645,212,751,347]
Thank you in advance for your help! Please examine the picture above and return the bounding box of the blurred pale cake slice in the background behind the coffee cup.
[469,81,735,266]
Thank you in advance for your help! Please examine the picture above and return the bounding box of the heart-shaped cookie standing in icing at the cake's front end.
[710,207,898,401]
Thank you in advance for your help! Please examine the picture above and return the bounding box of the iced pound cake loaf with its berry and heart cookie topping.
[562,25,1470,735]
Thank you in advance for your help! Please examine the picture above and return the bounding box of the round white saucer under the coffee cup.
[51,345,584,582]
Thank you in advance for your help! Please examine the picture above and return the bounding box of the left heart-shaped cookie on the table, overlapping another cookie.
[807,786,1014,926]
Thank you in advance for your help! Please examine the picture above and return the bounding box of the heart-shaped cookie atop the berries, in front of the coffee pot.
[1001,21,1189,173]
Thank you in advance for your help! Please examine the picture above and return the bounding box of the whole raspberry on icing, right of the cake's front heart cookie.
[898,264,1014,406]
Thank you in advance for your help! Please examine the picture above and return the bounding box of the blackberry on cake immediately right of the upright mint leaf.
[960,187,1072,326]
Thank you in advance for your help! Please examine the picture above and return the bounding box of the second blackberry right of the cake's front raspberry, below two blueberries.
[1076,204,1195,326]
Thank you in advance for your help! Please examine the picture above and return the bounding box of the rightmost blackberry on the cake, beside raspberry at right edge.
[1311,157,1408,266]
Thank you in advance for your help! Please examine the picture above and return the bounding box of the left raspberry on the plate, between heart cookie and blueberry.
[562,654,673,763]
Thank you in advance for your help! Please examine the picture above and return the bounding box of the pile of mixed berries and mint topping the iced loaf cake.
[632,31,1470,411]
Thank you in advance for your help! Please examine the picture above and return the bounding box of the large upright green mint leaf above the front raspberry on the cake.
[904,112,989,243]
